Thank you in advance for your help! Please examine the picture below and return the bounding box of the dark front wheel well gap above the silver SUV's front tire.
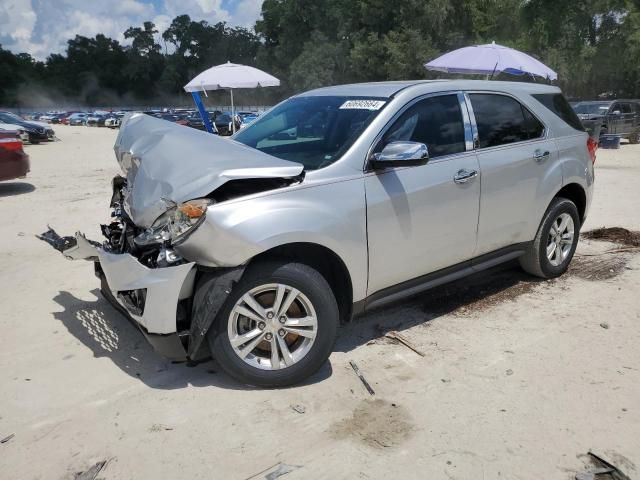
[247,242,353,323]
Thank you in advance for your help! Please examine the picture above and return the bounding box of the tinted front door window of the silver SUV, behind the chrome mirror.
[376,94,465,158]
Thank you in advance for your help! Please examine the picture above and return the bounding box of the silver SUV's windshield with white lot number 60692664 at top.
[234,96,387,170]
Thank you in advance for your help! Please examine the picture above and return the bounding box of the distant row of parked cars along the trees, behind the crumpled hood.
[23,109,259,135]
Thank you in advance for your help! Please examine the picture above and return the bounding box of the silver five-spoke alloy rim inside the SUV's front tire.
[227,283,318,370]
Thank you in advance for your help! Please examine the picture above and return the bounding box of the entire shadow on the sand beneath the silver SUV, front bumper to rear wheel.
[53,263,541,390]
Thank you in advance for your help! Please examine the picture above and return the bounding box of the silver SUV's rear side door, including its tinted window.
[468,92,562,256]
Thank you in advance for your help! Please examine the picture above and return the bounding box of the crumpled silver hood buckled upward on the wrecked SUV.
[114,113,304,227]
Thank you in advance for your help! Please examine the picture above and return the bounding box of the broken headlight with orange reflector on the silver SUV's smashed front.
[134,198,213,246]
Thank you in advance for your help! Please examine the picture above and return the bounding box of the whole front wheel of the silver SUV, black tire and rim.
[207,262,339,388]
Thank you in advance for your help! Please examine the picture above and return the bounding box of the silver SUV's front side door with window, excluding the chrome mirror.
[365,94,480,294]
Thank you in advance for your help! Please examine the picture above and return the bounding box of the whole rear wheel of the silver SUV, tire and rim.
[520,197,580,278]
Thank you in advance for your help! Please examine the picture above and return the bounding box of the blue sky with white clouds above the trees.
[0,0,262,60]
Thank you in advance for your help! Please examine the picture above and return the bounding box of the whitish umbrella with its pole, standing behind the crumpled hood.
[184,62,280,132]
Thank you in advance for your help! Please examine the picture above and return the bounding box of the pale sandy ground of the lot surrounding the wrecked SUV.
[0,126,640,480]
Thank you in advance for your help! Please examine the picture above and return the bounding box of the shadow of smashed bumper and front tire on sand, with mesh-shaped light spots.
[53,289,332,390]
